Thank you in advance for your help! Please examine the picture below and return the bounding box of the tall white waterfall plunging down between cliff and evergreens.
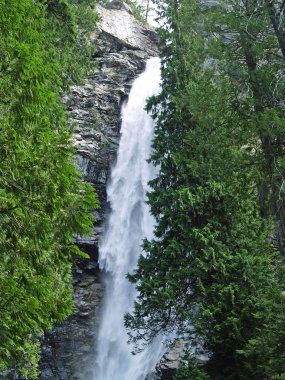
[93,58,164,380]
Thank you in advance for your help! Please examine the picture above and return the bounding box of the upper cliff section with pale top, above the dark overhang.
[69,1,158,245]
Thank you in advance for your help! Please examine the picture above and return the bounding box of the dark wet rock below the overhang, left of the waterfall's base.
[40,272,103,380]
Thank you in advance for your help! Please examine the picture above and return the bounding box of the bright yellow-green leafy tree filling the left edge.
[0,0,98,378]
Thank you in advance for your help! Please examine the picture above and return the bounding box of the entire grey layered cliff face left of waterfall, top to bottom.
[40,5,157,380]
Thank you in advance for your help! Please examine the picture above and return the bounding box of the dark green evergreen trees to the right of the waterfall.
[126,0,285,380]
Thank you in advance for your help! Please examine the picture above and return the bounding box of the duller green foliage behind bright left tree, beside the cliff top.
[43,0,98,86]
